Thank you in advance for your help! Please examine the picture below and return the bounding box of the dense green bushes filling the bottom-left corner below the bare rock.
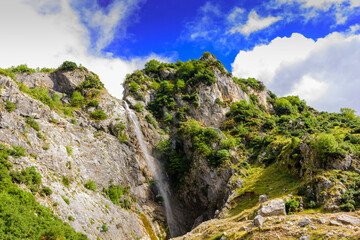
[0,146,87,240]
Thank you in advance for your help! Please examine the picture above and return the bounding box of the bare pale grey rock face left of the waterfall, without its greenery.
[0,70,165,239]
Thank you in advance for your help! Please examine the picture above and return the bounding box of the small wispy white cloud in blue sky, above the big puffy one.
[230,11,282,36]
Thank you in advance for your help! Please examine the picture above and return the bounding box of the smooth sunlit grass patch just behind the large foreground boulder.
[229,164,301,217]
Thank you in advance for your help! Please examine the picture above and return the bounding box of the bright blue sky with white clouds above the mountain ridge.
[0,0,360,114]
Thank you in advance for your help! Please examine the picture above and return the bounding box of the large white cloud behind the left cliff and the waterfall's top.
[0,0,166,98]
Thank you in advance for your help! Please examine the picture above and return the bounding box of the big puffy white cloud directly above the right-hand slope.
[232,27,360,113]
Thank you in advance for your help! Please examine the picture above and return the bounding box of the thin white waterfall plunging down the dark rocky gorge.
[124,101,180,237]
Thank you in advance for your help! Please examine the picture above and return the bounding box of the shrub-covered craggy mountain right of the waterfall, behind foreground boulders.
[124,53,360,239]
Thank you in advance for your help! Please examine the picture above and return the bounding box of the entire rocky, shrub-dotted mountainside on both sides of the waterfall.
[0,53,360,239]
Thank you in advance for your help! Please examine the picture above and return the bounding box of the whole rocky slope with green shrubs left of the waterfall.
[0,62,167,239]
